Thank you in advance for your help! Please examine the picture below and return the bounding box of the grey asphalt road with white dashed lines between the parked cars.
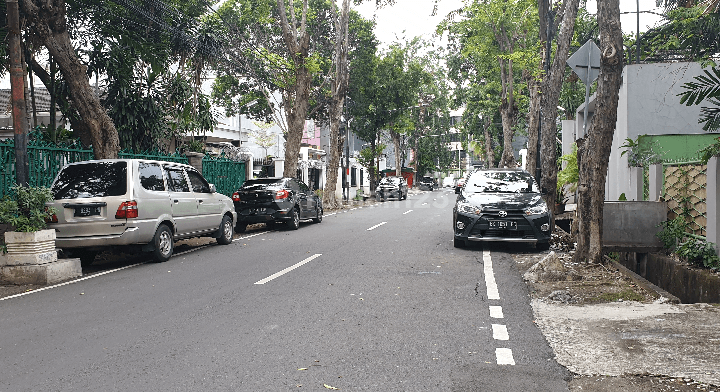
[0,190,568,392]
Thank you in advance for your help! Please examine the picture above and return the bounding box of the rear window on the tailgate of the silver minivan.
[52,161,127,200]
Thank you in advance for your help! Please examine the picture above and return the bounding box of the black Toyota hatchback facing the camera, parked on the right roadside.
[453,169,550,249]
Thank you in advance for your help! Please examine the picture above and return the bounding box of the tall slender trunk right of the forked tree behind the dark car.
[323,0,350,208]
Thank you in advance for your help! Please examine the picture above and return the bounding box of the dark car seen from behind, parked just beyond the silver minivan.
[232,178,323,233]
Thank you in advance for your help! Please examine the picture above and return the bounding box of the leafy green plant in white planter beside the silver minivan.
[0,185,57,265]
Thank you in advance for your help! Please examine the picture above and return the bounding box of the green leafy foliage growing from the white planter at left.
[0,185,56,233]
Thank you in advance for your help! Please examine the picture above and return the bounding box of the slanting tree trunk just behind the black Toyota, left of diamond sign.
[540,0,580,224]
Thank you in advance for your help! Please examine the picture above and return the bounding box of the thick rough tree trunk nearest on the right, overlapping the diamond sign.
[575,0,623,263]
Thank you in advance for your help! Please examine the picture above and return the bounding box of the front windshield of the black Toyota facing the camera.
[465,171,538,193]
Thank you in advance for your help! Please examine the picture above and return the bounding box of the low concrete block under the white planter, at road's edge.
[0,259,82,285]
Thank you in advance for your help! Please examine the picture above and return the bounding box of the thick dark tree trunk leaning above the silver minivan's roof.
[20,0,120,159]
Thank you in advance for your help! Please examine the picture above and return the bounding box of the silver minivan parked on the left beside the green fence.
[48,159,237,265]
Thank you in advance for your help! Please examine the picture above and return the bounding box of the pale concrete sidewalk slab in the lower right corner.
[532,299,720,386]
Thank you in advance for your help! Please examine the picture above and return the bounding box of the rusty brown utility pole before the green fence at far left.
[6,0,30,186]
